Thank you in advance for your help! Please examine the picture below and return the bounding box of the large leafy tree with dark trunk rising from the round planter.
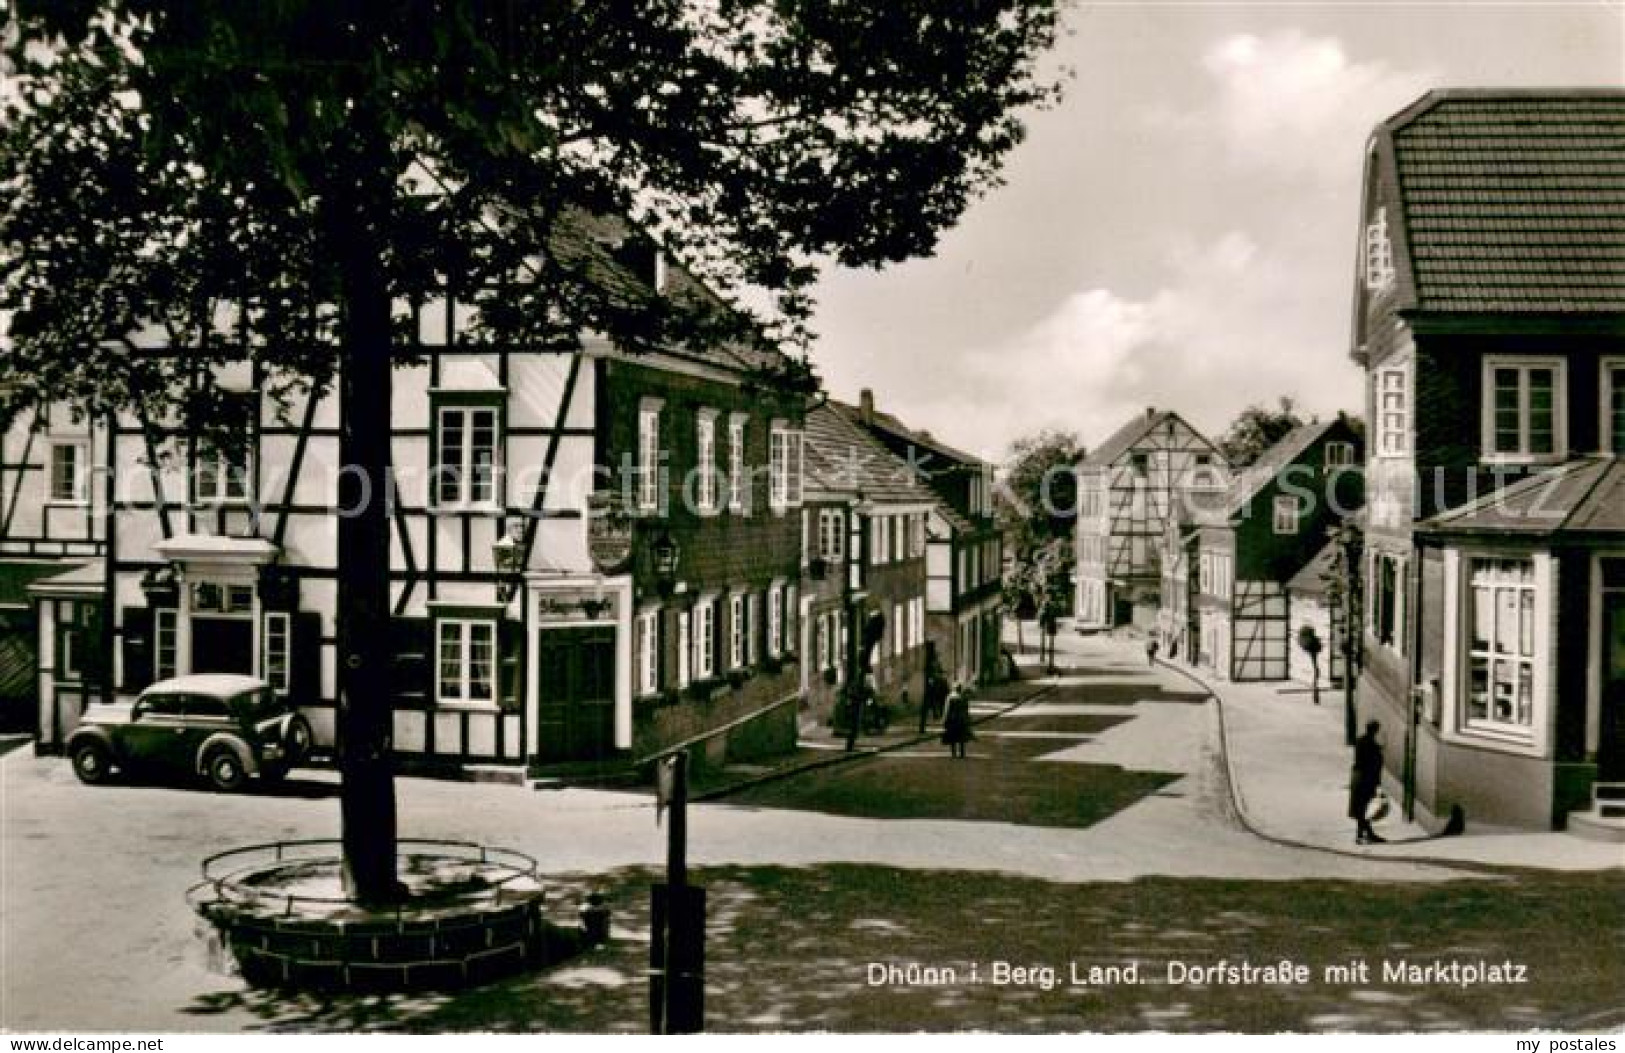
[0,0,1056,902]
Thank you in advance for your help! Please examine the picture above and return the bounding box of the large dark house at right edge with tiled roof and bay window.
[1352,89,1625,839]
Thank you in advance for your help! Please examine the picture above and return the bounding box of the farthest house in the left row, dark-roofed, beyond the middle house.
[856,388,1004,684]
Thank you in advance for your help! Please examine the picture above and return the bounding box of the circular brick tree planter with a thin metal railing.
[187,840,557,991]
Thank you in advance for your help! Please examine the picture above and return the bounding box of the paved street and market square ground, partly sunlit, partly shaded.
[0,642,1625,1030]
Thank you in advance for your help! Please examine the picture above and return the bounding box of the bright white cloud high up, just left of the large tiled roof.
[1147,29,1437,180]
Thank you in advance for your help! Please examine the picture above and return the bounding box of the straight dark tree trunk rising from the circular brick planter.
[330,205,401,904]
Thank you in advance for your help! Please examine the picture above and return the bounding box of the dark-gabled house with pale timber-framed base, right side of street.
[1173,416,1363,681]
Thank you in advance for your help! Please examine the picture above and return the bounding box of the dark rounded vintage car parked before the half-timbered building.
[67,674,312,791]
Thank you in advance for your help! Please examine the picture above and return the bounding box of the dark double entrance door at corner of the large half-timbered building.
[536,626,616,762]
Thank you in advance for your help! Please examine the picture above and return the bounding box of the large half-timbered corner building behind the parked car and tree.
[79,217,804,775]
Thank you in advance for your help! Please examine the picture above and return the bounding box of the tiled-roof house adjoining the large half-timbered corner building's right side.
[801,403,936,723]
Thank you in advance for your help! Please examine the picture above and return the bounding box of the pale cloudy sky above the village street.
[813,0,1625,460]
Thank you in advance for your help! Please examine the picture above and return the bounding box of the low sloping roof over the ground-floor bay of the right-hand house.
[1417,457,1625,538]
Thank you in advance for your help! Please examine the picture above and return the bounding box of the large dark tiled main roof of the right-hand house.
[1380,89,1625,314]
